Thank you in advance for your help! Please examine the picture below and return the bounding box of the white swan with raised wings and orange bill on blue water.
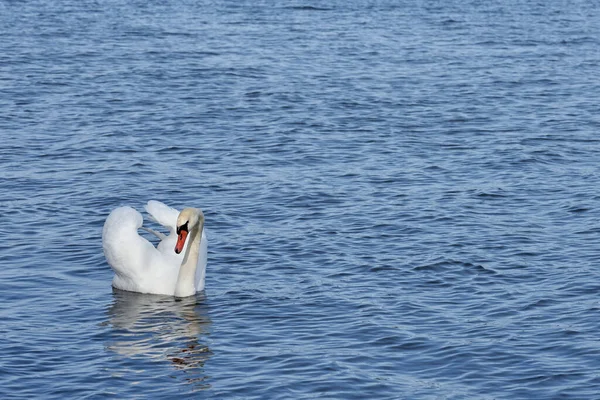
[102,200,208,297]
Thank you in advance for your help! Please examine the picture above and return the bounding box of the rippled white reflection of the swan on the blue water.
[107,288,211,388]
